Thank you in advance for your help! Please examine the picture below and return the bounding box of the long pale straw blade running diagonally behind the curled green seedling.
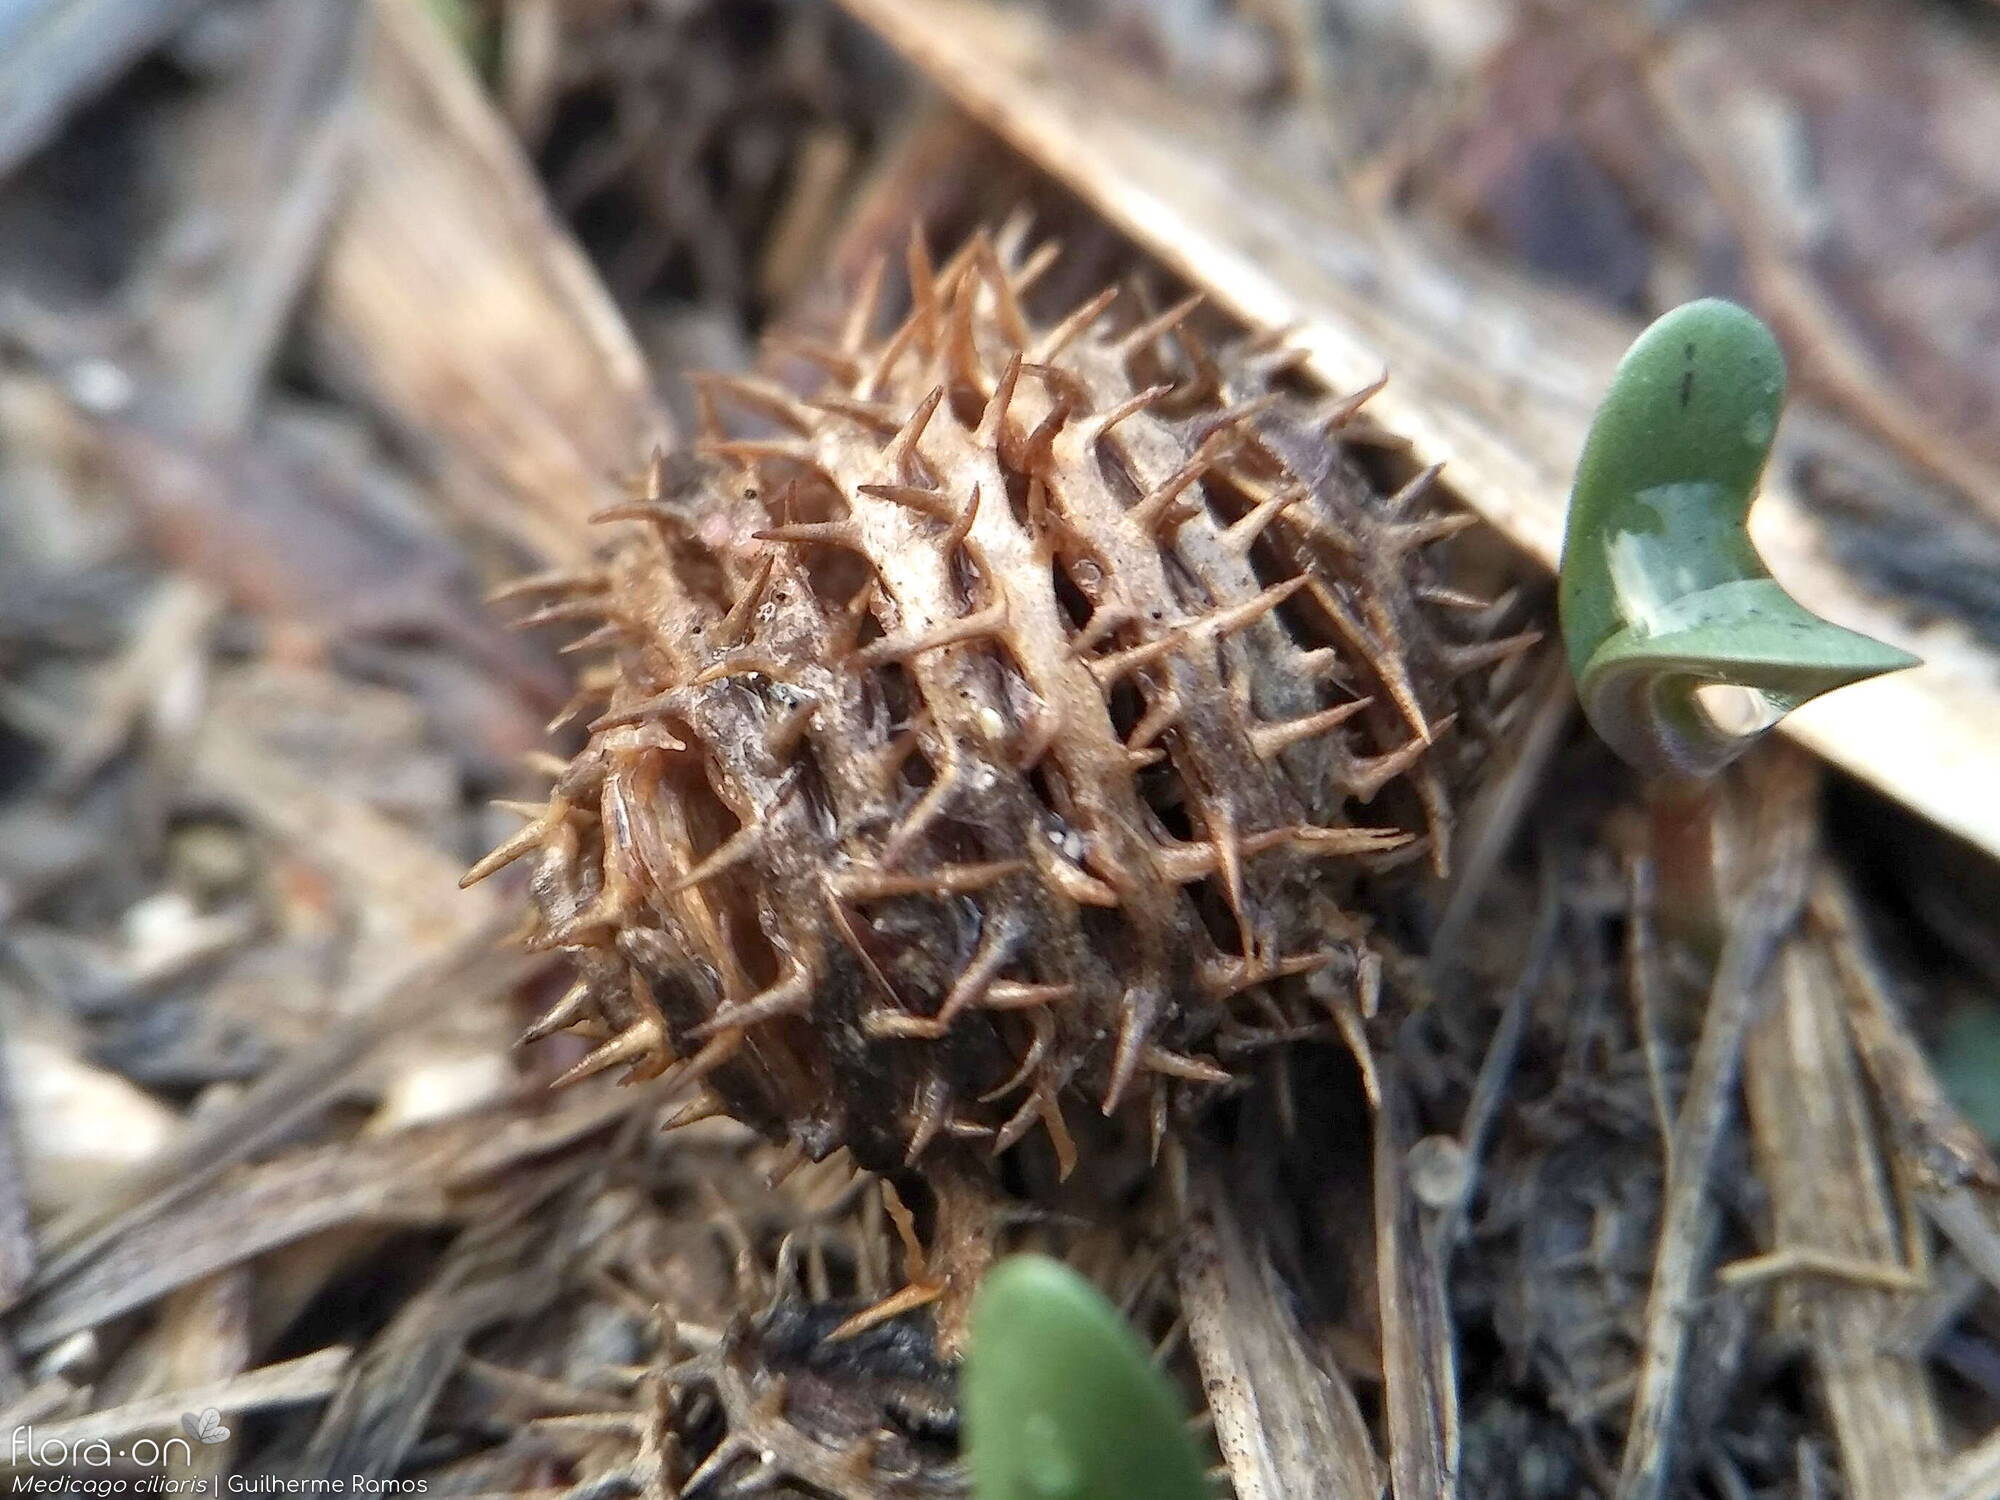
[828,0,2000,854]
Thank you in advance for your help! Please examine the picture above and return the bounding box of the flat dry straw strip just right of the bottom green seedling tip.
[1178,1170,1382,1500]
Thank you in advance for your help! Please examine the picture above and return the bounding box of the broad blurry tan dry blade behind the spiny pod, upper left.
[312,0,666,560]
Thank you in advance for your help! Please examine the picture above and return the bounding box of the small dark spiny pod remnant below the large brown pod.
[576,1152,972,1500]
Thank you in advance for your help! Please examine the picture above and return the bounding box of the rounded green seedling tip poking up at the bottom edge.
[964,1256,1206,1500]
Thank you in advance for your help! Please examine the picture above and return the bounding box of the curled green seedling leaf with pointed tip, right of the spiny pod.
[1560,298,1918,776]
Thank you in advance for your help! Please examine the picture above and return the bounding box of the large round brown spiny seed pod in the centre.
[468,236,1532,1170]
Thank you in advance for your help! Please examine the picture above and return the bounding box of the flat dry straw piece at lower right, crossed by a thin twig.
[1744,936,1942,1500]
